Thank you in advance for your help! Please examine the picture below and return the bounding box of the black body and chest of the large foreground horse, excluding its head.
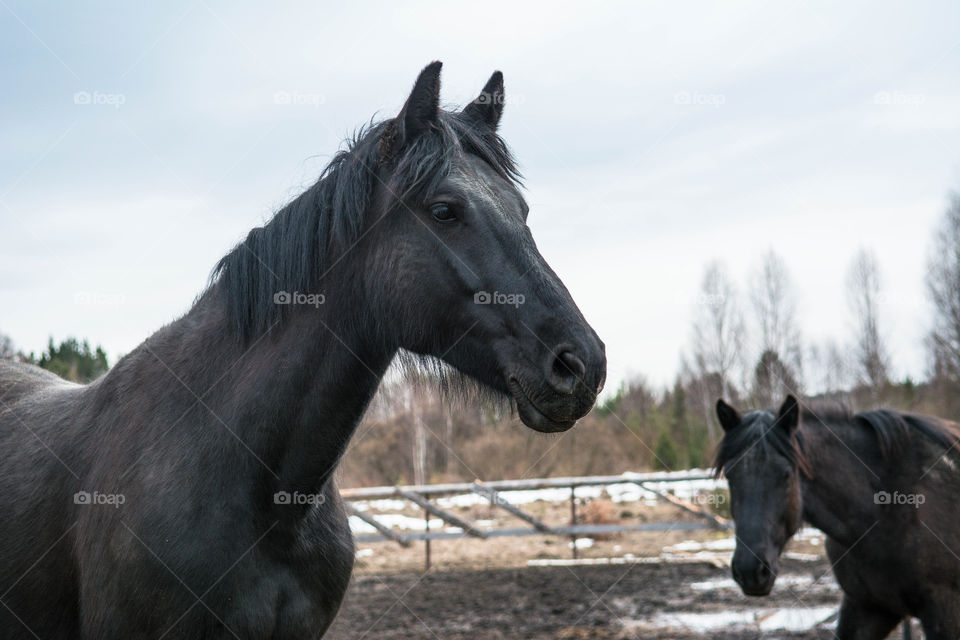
[0,288,374,638]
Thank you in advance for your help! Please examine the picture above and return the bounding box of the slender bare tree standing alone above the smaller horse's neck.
[847,248,890,395]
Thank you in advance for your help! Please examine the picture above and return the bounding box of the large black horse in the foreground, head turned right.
[0,62,606,640]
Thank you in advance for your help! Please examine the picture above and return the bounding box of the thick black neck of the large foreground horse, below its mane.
[111,264,396,494]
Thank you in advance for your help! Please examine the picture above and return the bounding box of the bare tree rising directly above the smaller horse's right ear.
[750,250,803,406]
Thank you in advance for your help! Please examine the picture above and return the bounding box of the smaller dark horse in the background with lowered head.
[716,396,960,640]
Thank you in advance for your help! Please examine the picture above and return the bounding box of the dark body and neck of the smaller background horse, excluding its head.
[802,419,960,638]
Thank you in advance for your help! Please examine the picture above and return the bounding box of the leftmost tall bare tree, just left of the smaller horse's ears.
[693,262,745,438]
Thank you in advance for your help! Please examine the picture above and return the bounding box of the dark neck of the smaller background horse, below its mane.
[801,425,876,546]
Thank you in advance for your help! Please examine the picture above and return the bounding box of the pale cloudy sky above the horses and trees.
[0,0,960,388]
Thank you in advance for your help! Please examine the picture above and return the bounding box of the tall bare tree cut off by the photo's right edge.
[926,194,960,382]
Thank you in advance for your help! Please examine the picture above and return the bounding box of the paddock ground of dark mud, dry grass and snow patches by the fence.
[325,492,922,640]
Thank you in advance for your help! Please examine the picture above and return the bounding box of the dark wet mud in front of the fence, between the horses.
[329,562,839,640]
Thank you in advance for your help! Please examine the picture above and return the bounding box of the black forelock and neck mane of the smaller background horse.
[713,401,960,476]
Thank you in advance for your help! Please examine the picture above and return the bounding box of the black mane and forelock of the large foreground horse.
[207,110,520,343]
